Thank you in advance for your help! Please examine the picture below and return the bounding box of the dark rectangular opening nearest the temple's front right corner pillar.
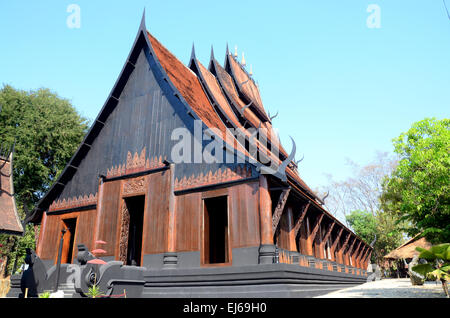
[203,196,229,264]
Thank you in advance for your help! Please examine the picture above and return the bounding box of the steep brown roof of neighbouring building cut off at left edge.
[0,151,23,235]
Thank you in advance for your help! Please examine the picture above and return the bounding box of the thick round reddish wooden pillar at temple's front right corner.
[259,174,275,264]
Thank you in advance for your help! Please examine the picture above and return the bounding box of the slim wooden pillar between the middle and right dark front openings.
[163,163,178,268]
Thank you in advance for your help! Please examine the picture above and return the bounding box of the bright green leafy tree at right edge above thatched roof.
[381,118,450,243]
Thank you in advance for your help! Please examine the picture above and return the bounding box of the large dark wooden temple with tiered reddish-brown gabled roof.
[12,13,372,297]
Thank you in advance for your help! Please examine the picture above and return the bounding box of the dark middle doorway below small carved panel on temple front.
[125,195,145,266]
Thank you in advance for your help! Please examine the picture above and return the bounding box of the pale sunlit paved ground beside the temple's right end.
[316,278,446,298]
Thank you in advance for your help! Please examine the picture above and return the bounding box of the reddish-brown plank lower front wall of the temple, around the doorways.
[40,171,260,259]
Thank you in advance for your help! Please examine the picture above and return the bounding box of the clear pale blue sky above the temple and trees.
[0,0,450,188]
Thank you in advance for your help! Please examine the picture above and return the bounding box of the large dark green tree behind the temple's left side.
[0,85,88,271]
